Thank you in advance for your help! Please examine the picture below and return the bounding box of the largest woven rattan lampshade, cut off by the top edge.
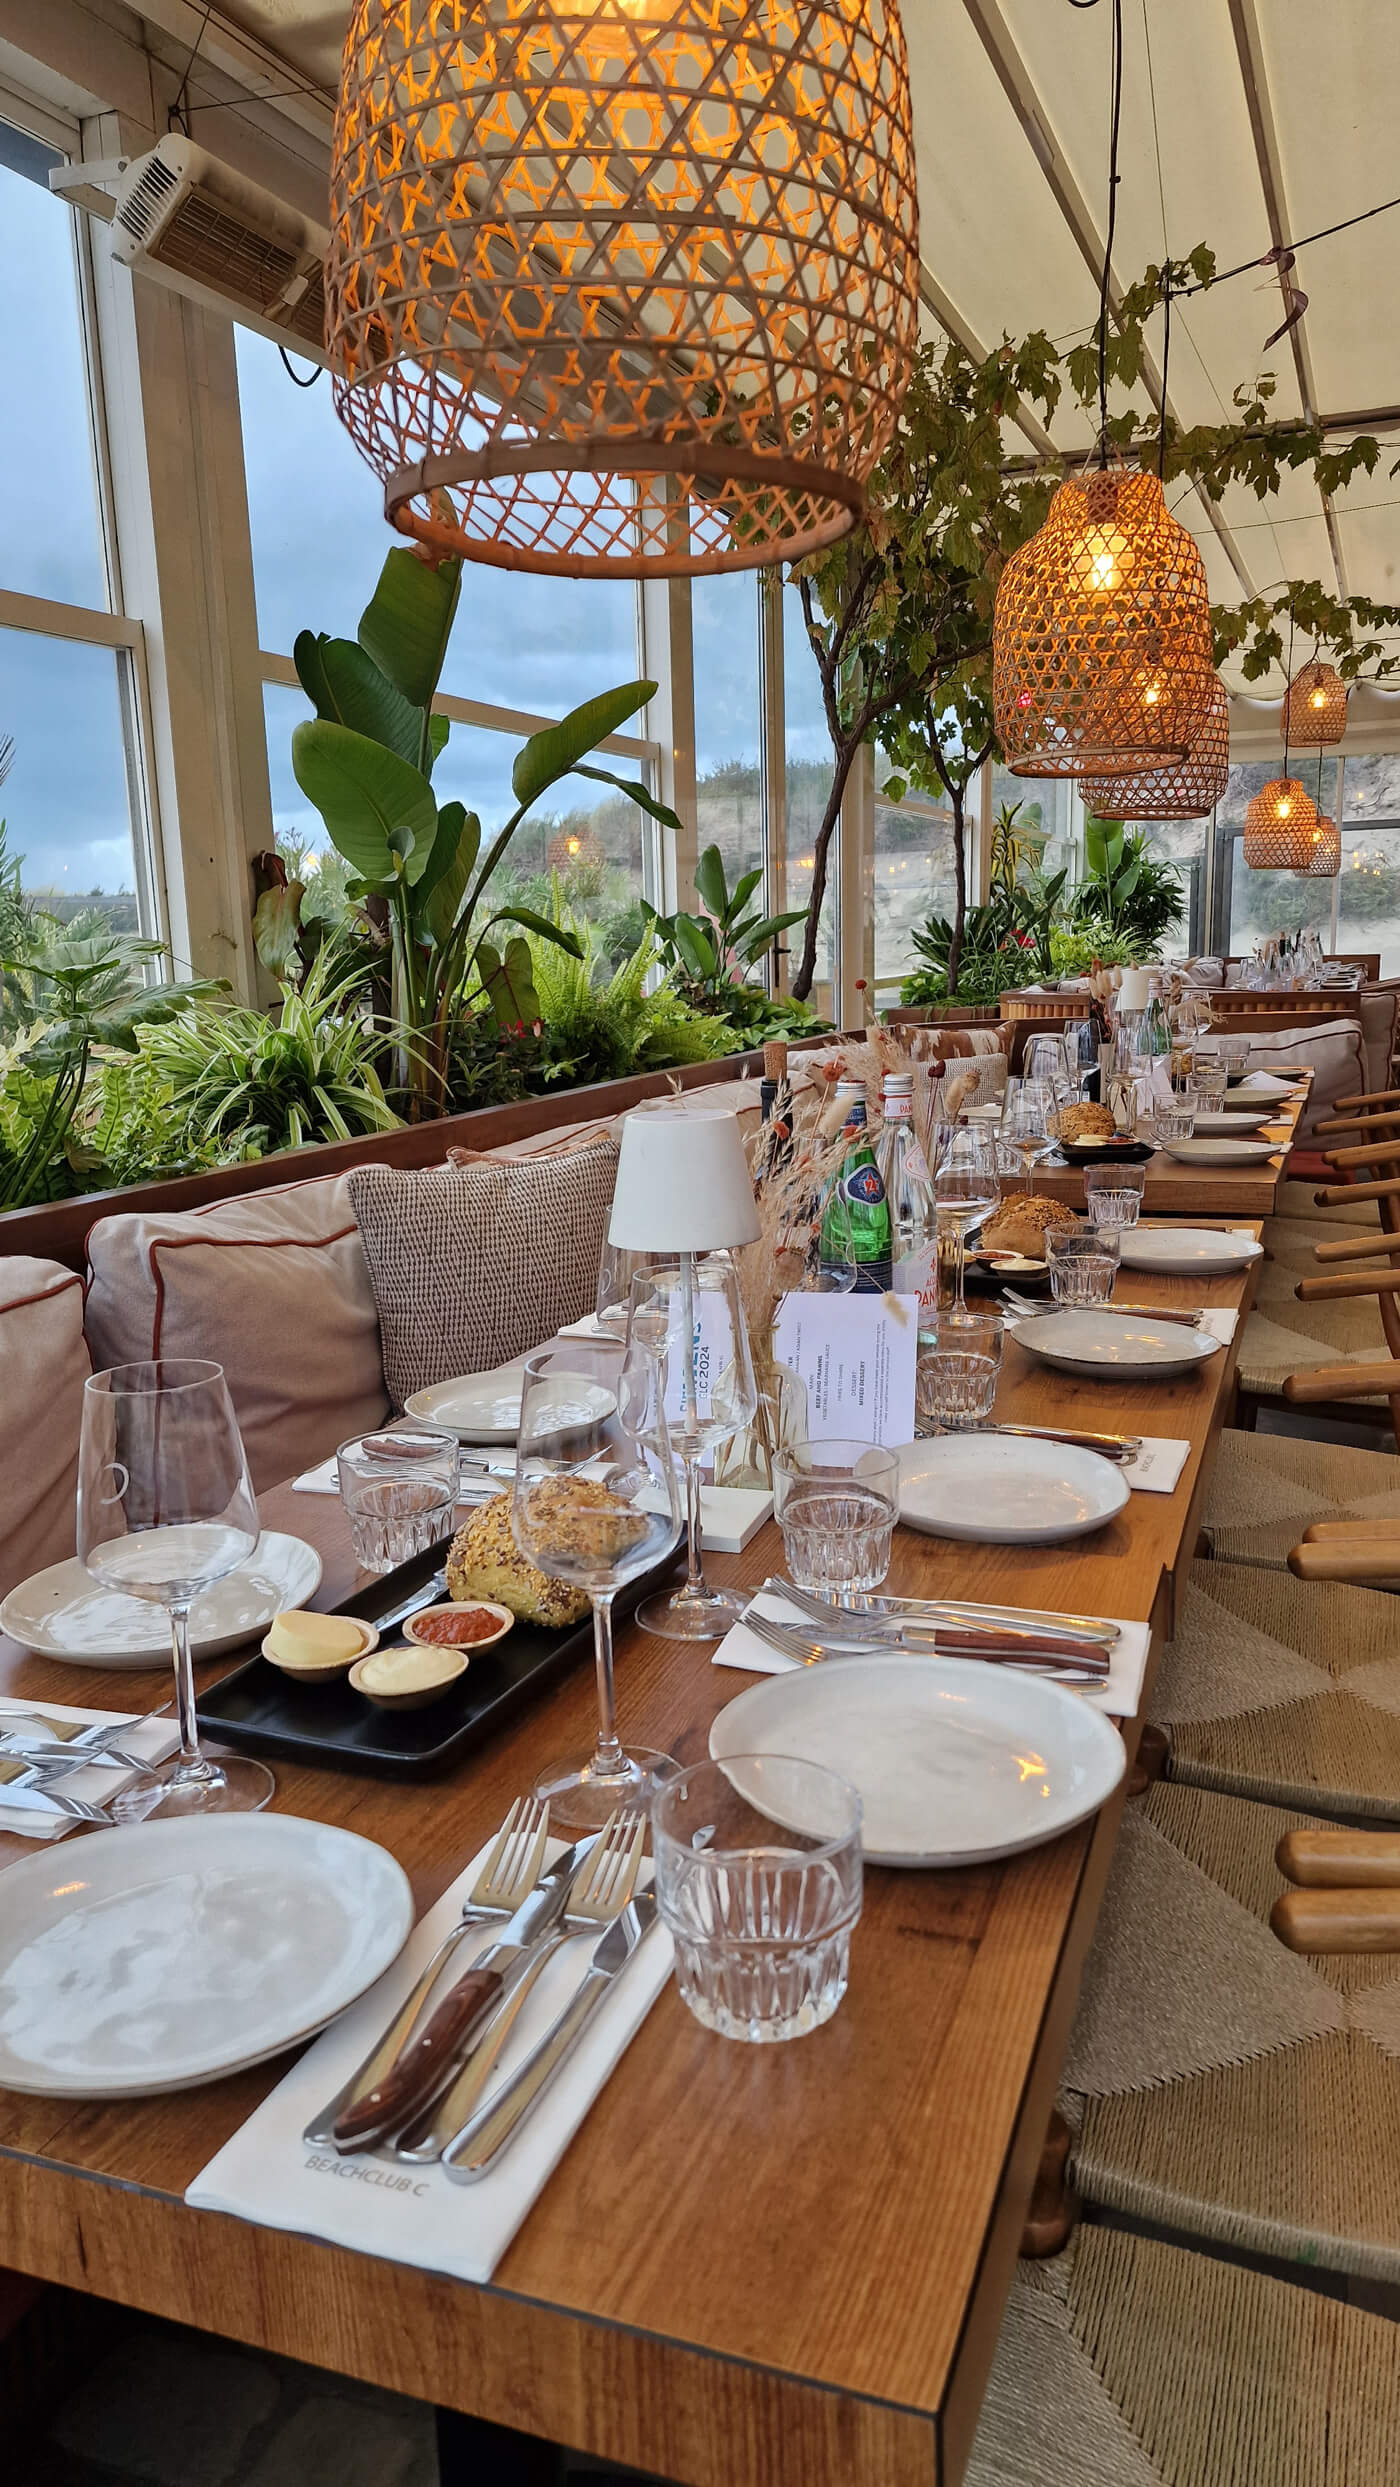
[326,0,918,577]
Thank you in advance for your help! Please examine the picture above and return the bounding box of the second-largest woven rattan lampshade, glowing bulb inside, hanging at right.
[992,470,1213,776]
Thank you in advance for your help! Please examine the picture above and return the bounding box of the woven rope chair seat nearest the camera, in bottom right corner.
[965,2228,1400,2487]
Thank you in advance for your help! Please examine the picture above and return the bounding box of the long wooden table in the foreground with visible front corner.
[0,1253,1253,2487]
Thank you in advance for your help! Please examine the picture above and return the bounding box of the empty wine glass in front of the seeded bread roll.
[510,1338,681,1830]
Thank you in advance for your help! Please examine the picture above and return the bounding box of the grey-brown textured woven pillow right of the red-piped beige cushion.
[348,1134,617,1408]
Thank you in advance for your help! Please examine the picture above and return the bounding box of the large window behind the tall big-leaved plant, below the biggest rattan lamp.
[236,328,649,948]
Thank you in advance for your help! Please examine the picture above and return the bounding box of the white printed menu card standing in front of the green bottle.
[773,1296,918,1442]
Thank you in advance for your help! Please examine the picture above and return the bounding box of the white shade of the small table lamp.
[607,1112,758,1251]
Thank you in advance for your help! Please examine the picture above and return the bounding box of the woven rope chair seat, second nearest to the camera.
[1059,1783,1400,2278]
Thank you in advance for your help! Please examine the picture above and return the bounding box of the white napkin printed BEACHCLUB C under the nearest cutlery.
[184,1840,671,2283]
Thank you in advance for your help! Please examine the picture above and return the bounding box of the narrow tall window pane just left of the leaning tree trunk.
[681,570,763,905]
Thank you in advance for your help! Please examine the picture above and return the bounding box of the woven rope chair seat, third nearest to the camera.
[1151,1559,1400,1823]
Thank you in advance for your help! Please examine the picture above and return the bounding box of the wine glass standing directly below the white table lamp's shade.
[629,1251,758,1641]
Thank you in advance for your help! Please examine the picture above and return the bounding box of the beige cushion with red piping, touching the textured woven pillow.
[87,1174,388,1492]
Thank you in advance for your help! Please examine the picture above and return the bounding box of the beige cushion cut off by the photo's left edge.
[0,1253,92,1597]
